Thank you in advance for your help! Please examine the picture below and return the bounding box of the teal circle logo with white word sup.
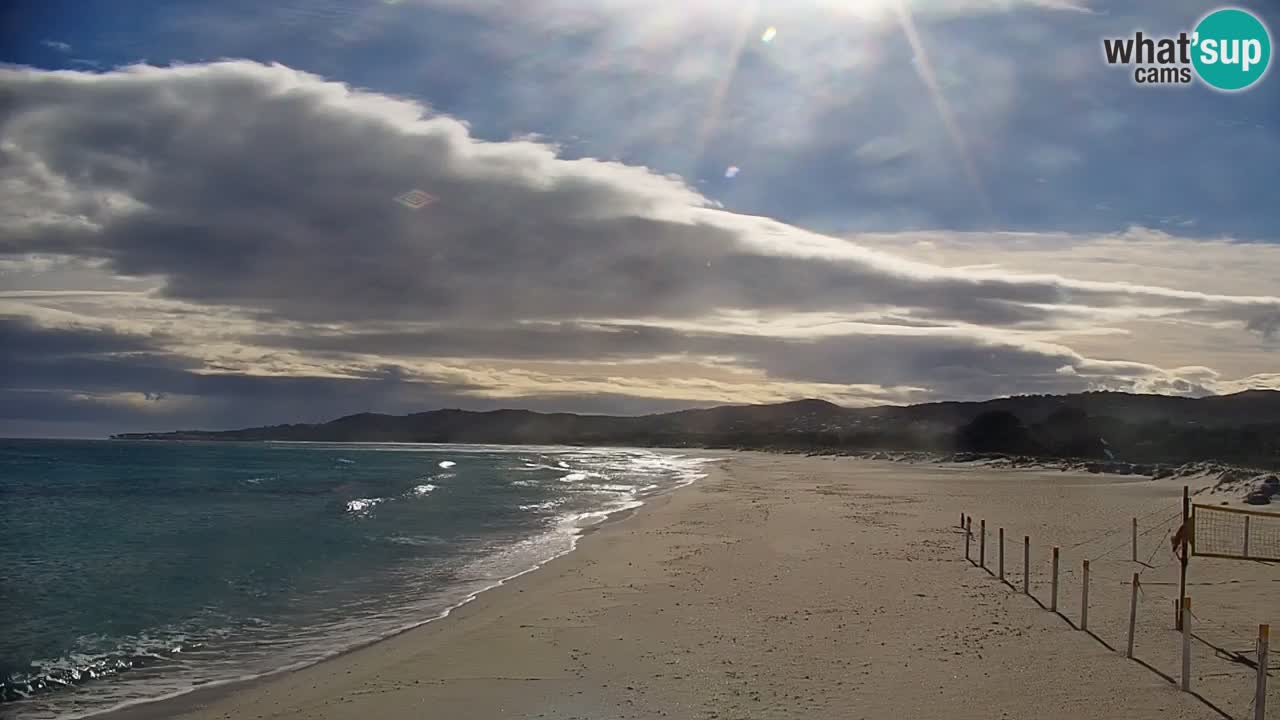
[1192,8,1271,92]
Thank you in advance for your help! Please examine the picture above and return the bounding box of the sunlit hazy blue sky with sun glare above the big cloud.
[102,0,1280,240]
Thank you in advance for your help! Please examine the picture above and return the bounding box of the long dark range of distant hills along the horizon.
[113,391,1280,468]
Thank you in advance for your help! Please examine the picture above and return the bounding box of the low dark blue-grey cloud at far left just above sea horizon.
[0,316,474,436]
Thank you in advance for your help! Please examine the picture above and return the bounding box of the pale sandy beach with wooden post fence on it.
[111,454,1280,720]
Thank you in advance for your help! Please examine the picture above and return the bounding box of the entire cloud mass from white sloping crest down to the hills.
[0,60,1280,424]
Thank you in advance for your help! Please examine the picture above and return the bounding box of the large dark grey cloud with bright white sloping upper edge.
[0,61,1274,325]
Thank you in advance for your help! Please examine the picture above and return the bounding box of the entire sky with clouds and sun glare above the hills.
[0,0,1280,437]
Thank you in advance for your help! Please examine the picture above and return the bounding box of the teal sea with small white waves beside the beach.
[0,439,708,720]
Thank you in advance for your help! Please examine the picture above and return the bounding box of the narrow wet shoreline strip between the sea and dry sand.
[83,453,724,720]
